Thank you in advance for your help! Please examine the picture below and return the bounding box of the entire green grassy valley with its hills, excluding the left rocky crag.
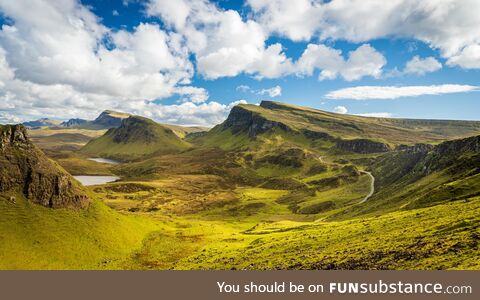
[0,101,480,270]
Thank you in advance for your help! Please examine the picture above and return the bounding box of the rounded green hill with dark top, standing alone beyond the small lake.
[81,116,190,161]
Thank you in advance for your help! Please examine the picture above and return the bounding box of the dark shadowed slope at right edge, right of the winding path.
[337,136,480,218]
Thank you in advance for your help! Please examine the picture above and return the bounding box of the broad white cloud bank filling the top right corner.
[247,0,480,69]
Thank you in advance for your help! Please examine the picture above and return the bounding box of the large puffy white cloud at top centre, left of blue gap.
[147,0,292,79]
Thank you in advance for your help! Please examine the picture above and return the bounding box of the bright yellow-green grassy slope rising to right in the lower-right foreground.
[170,198,480,269]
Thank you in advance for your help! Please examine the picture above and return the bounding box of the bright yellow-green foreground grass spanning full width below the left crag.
[0,190,480,269]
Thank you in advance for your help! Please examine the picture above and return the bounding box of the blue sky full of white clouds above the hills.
[0,0,480,125]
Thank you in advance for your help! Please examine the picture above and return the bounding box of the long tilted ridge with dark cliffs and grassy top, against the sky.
[200,101,480,146]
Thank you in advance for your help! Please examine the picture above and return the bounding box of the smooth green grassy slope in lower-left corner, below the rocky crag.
[0,195,158,269]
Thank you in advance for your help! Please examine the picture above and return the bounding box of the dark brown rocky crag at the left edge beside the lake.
[0,125,89,208]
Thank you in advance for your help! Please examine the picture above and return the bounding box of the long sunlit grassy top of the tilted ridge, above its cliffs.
[233,101,480,144]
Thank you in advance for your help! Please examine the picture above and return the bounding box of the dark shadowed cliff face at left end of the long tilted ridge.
[223,106,291,138]
